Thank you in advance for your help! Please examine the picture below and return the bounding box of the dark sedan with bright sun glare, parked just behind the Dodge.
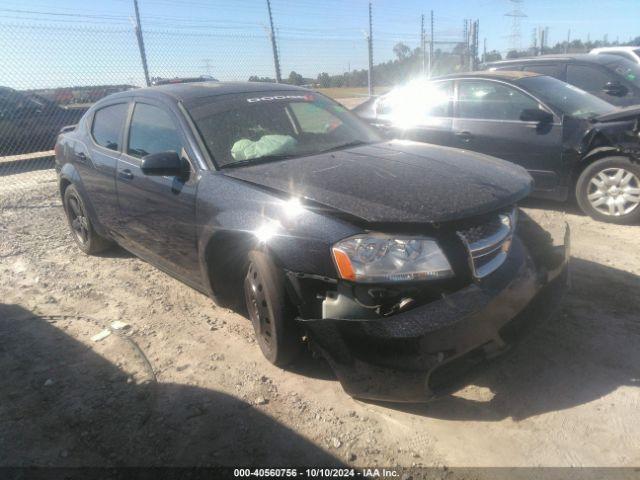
[354,71,640,223]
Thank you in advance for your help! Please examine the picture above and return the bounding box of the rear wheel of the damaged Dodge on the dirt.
[63,185,113,255]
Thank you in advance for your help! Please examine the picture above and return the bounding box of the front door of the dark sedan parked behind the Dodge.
[453,79,563,190]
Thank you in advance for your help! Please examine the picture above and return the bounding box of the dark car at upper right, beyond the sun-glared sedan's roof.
[485,53,640,107]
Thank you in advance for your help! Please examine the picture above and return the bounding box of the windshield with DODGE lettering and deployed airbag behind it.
[187,91,381,167]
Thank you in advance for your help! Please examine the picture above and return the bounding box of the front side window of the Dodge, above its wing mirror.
[127,103,183,158]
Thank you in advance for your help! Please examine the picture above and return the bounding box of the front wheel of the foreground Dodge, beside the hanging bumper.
[244,251,302,367]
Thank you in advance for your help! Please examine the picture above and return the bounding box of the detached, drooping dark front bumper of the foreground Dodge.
[300,220,570,402]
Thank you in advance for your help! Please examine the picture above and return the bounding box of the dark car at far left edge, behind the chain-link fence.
[0,87,86,156]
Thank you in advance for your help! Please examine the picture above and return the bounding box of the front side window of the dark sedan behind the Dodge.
[457,80,540,121]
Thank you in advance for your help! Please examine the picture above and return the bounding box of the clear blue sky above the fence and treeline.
[0,0,640,89]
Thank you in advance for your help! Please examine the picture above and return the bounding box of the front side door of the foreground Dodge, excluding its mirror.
[116,98,201,283]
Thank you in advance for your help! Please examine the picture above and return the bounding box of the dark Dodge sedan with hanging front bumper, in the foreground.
[56,82,568,400]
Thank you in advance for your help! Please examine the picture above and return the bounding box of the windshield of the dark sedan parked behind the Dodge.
[518,76,616,118]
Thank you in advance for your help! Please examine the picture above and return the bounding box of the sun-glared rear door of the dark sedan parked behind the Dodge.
[377,80,454,146]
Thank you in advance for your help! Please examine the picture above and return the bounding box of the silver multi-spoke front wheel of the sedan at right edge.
[576,156,640,225]
